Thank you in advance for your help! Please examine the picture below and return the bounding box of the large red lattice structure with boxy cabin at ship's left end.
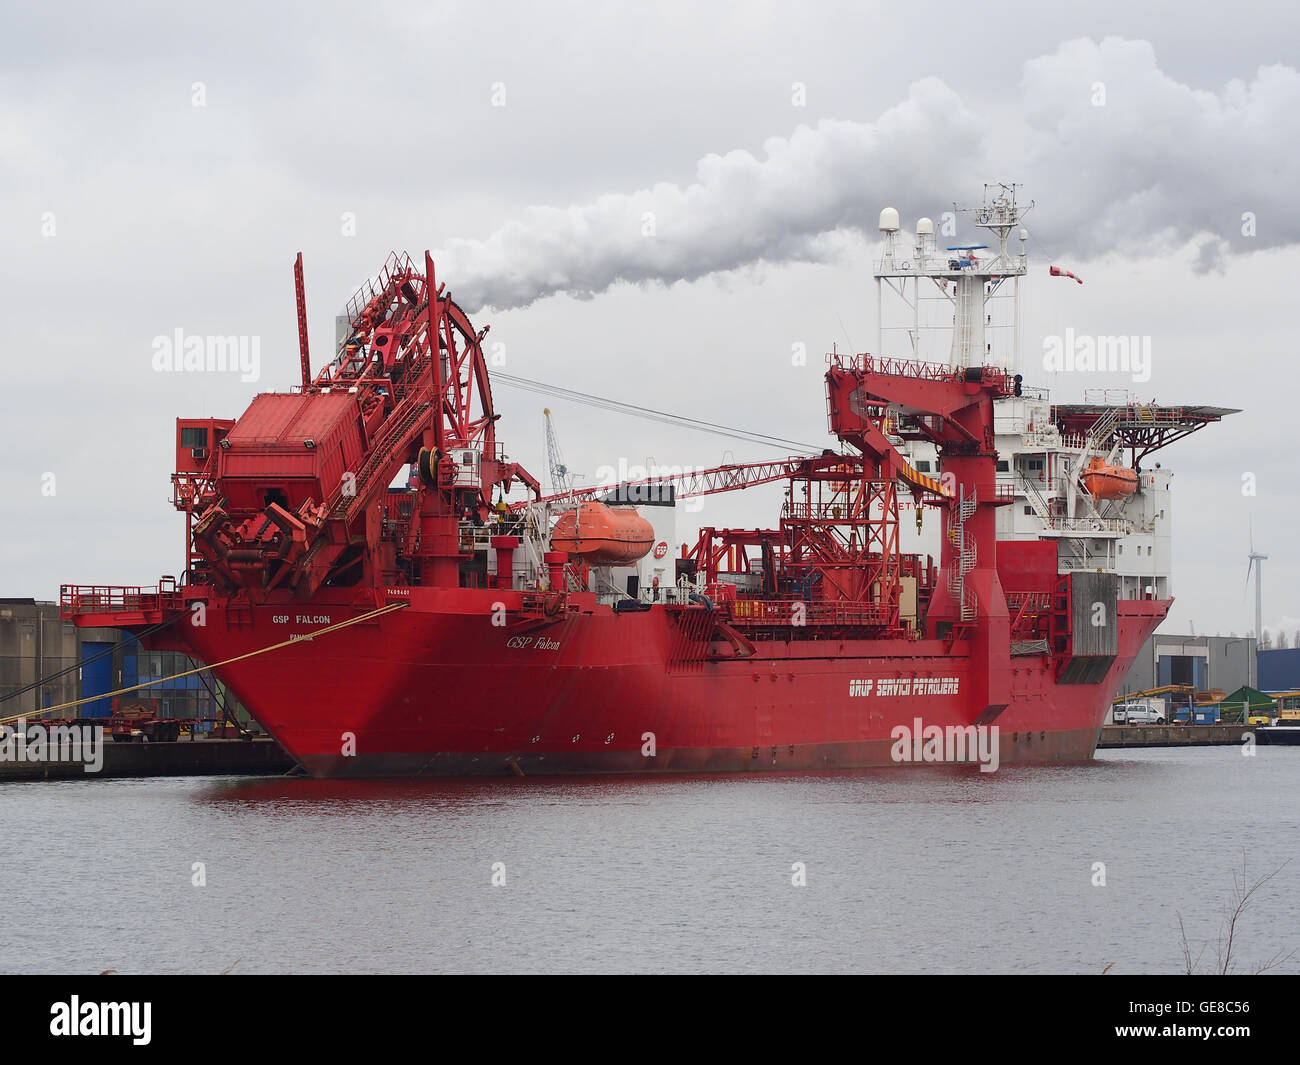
[173,252,541,599]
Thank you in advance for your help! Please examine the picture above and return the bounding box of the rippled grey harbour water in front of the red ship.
[0,748,1300,973]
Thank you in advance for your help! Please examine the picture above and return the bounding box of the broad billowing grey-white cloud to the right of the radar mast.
[1021,38,1300,261]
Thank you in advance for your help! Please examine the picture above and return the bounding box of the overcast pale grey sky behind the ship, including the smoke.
[0,0,1300,637]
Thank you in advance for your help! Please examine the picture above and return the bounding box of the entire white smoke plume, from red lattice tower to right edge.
[436,38,1300,311]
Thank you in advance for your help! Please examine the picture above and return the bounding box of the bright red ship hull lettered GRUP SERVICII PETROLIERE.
[142,589,1169,776]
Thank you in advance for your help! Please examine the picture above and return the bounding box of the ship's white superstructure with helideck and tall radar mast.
[875,185,1232,599]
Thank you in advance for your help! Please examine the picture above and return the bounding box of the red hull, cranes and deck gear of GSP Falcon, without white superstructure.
[62,191,1216,776]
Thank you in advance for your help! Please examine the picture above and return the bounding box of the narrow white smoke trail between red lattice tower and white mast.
[434,78,987,311]
